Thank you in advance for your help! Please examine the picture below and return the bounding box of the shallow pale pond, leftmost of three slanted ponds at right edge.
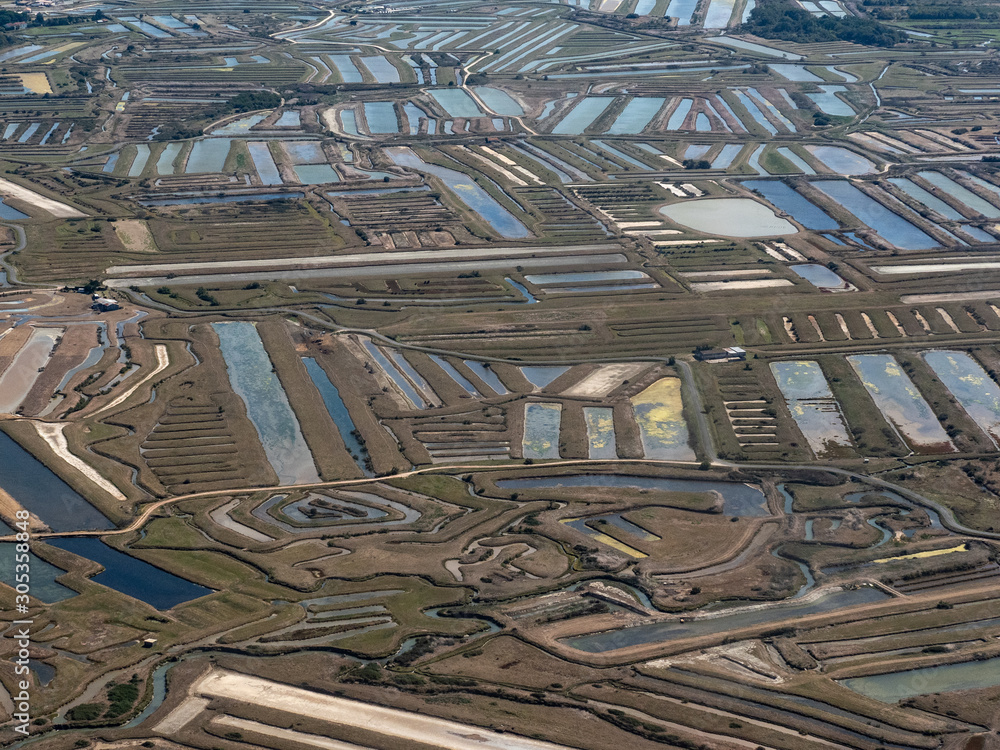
[771,361,851,456]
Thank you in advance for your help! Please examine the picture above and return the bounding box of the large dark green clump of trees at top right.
[741,0,906,47]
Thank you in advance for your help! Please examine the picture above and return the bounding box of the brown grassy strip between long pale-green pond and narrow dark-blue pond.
[257,320,361,479]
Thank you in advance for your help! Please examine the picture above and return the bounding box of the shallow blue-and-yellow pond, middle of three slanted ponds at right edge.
[847,354,955,453]
